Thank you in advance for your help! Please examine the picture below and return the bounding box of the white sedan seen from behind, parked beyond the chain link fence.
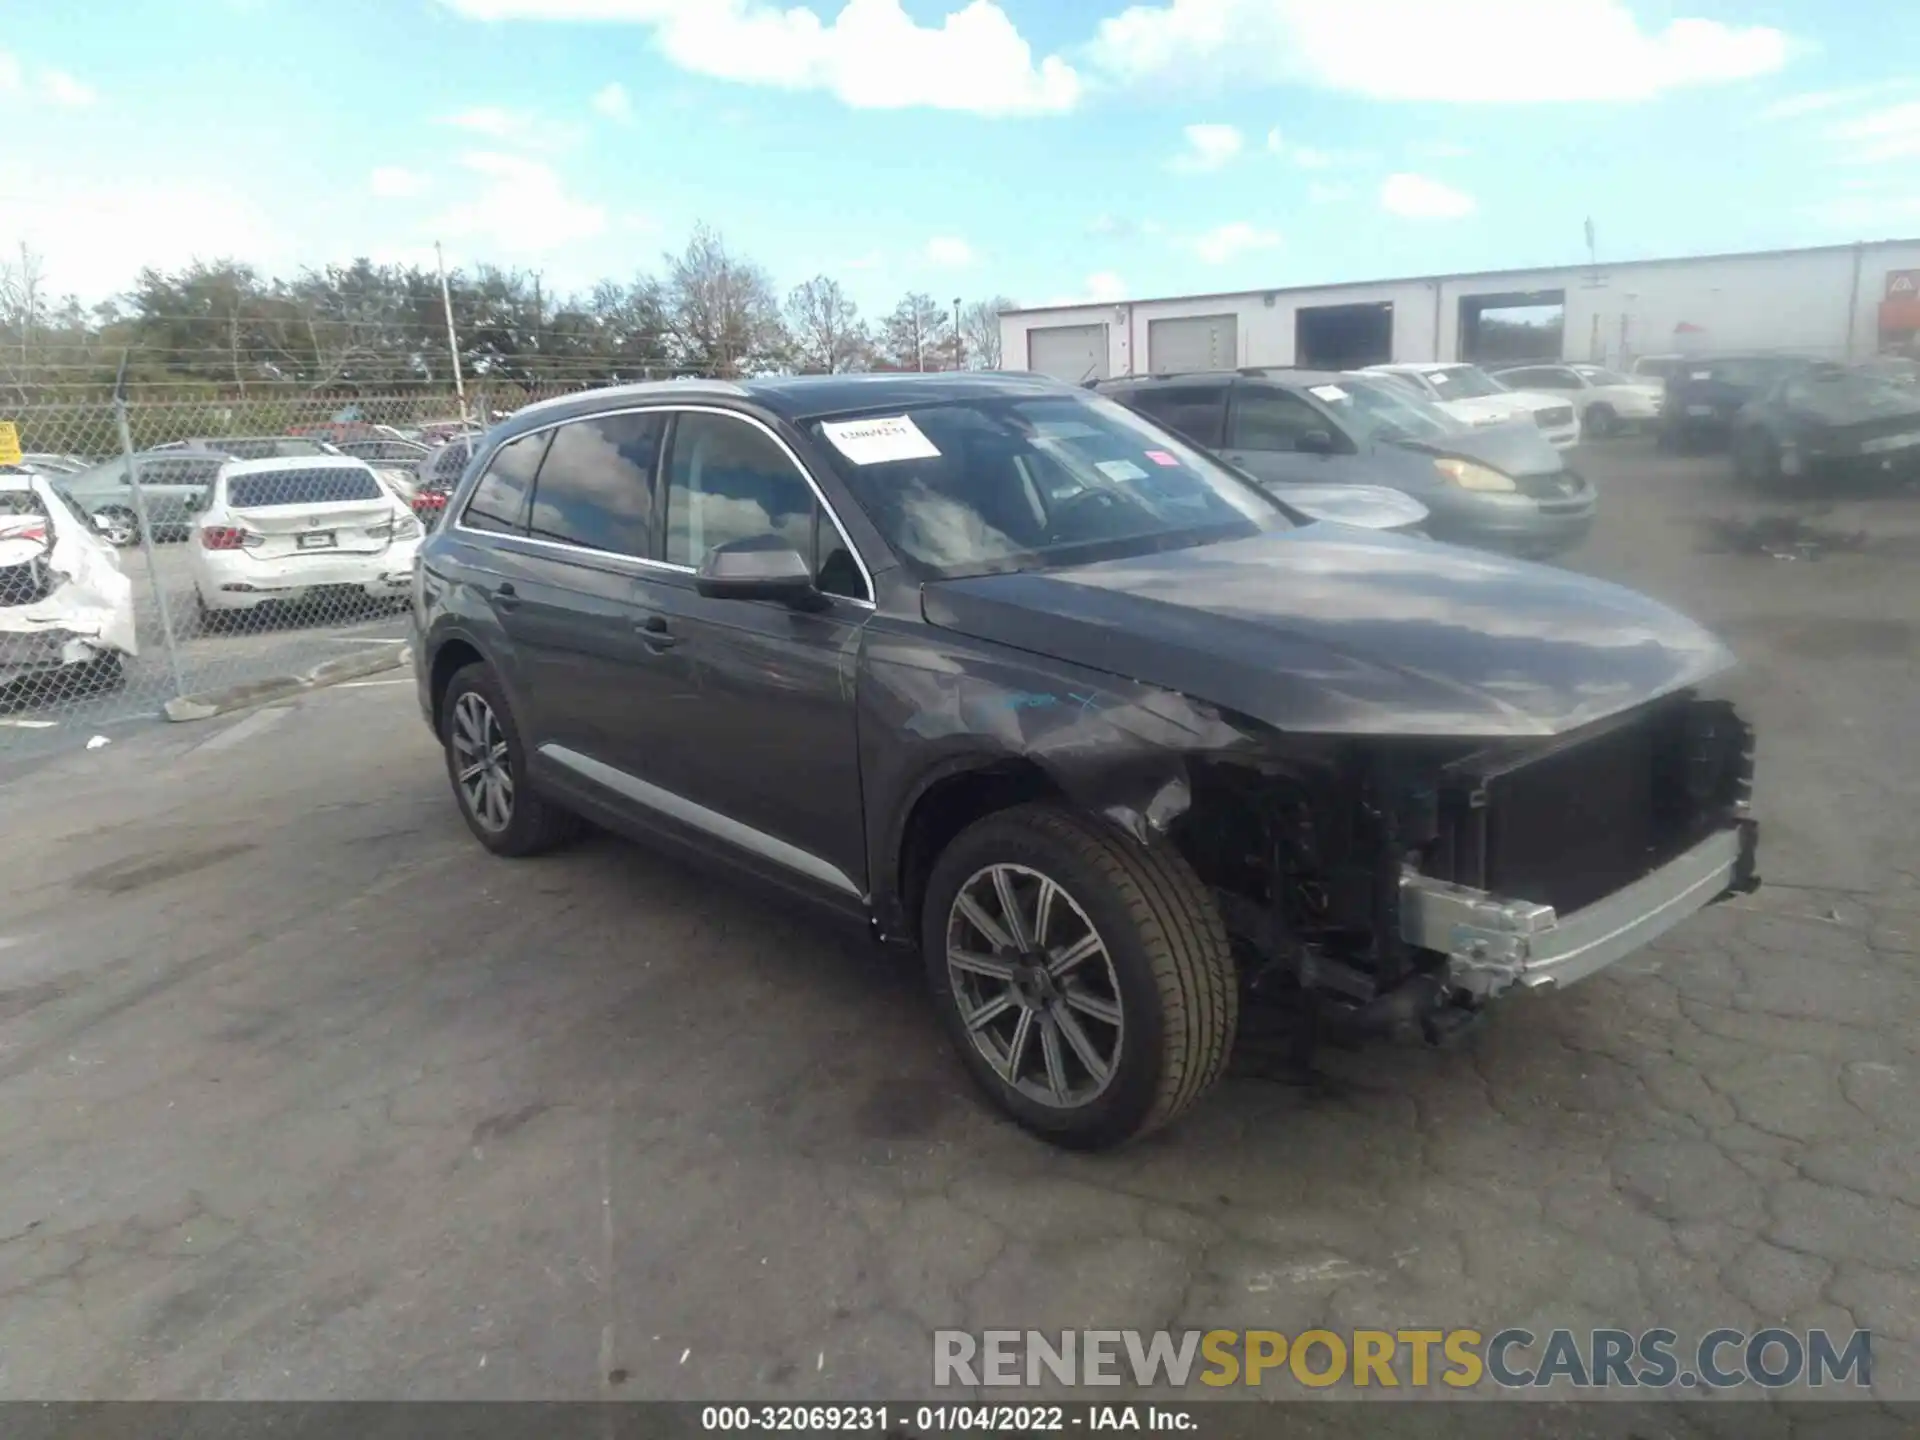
[188,455,424,620]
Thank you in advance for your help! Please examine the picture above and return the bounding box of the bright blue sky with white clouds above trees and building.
[0,0,1920,311]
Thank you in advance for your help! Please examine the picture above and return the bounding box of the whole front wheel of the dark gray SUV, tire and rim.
[922,804,1238,1150]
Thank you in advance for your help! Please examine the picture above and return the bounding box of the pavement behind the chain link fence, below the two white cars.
[0,543,407,744]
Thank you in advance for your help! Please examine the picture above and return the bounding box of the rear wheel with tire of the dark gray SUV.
[440,664,580,856]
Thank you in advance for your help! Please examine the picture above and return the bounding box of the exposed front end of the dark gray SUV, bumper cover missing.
[1165,691,1759,1043]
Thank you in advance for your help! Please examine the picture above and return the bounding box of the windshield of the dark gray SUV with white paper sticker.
[808,396,1286,578]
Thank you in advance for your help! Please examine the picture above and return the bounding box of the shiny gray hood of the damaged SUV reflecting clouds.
[922,524,1732,737]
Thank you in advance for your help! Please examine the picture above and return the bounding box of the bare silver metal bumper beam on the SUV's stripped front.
[1400,820,1759,1000]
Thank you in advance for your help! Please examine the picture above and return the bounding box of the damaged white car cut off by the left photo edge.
[0,468,138,689]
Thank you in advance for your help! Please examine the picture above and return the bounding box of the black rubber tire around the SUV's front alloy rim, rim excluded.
[922,804,1240,1150]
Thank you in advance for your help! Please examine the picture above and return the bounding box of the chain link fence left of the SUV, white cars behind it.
[0,386,578,751]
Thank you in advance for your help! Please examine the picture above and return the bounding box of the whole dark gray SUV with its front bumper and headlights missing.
[413,374,1755,1146]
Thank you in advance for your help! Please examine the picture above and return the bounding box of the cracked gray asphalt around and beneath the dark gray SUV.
[0,444,1920,1405]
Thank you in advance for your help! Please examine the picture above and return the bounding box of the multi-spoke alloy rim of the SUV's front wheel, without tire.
[947,864,1125,1110]
